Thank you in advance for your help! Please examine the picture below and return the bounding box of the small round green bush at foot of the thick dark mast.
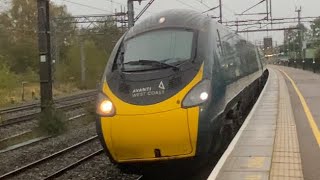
[39,108,67,135]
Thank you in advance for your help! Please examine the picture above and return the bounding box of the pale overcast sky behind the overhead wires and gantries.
[51,0,320,44]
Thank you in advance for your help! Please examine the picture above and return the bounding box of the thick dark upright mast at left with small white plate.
[37,0,52,111]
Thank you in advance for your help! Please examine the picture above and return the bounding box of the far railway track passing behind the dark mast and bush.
[0,90,97,128]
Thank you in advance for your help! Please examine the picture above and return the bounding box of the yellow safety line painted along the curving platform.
[278,69,320,147]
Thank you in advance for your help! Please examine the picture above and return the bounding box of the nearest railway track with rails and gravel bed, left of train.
[0,121,140,180]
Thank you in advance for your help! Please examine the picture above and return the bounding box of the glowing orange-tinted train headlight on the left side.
[96,93,115,117]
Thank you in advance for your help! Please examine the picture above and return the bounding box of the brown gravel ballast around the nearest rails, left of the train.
[0,116,138,180]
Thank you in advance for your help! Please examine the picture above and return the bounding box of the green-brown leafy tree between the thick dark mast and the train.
[55,17,122,88]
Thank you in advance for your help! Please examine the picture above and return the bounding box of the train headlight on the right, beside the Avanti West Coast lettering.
[182,80,211,108]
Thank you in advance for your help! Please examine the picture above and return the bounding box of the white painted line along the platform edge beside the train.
[208,68,274,180]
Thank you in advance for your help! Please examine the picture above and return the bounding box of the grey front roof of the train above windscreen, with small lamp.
[126,9,211,39]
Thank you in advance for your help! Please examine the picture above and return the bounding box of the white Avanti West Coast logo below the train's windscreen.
[132,81,166,98]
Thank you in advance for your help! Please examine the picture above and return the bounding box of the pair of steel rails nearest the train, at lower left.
[0,136,103,179]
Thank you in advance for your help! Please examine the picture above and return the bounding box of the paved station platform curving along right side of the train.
[208,66,320,180]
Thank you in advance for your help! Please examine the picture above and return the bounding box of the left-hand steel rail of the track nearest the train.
[0,136,98,179]
